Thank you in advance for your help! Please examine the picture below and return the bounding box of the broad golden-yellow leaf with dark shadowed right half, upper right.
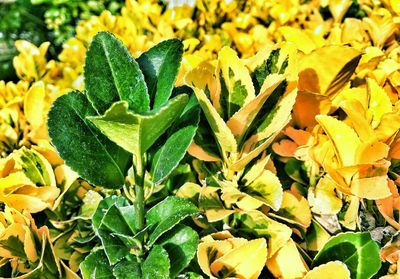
[299,46,361,96]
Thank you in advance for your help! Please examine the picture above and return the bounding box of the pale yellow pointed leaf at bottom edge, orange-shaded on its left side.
[267,239,308,279]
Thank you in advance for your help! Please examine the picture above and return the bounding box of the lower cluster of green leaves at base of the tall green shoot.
[81,196,199,279]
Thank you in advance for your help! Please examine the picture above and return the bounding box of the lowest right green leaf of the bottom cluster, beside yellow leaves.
[157,224,199,278]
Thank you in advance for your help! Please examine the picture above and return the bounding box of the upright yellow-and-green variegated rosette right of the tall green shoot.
[181,45,296,221]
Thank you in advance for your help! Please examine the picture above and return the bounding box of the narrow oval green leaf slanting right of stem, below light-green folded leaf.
[150,107,200,183]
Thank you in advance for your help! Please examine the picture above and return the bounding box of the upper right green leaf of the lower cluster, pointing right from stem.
[146,196,199,247]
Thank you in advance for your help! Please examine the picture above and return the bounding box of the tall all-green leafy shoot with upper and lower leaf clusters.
[48,32,200,278]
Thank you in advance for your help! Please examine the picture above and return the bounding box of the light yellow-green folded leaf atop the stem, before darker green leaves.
[87,95,188,157]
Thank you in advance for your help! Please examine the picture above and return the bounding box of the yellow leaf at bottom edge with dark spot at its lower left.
[210,238,267,279]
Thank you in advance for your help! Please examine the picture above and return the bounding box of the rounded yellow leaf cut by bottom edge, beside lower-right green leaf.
[304,261,350,279]
